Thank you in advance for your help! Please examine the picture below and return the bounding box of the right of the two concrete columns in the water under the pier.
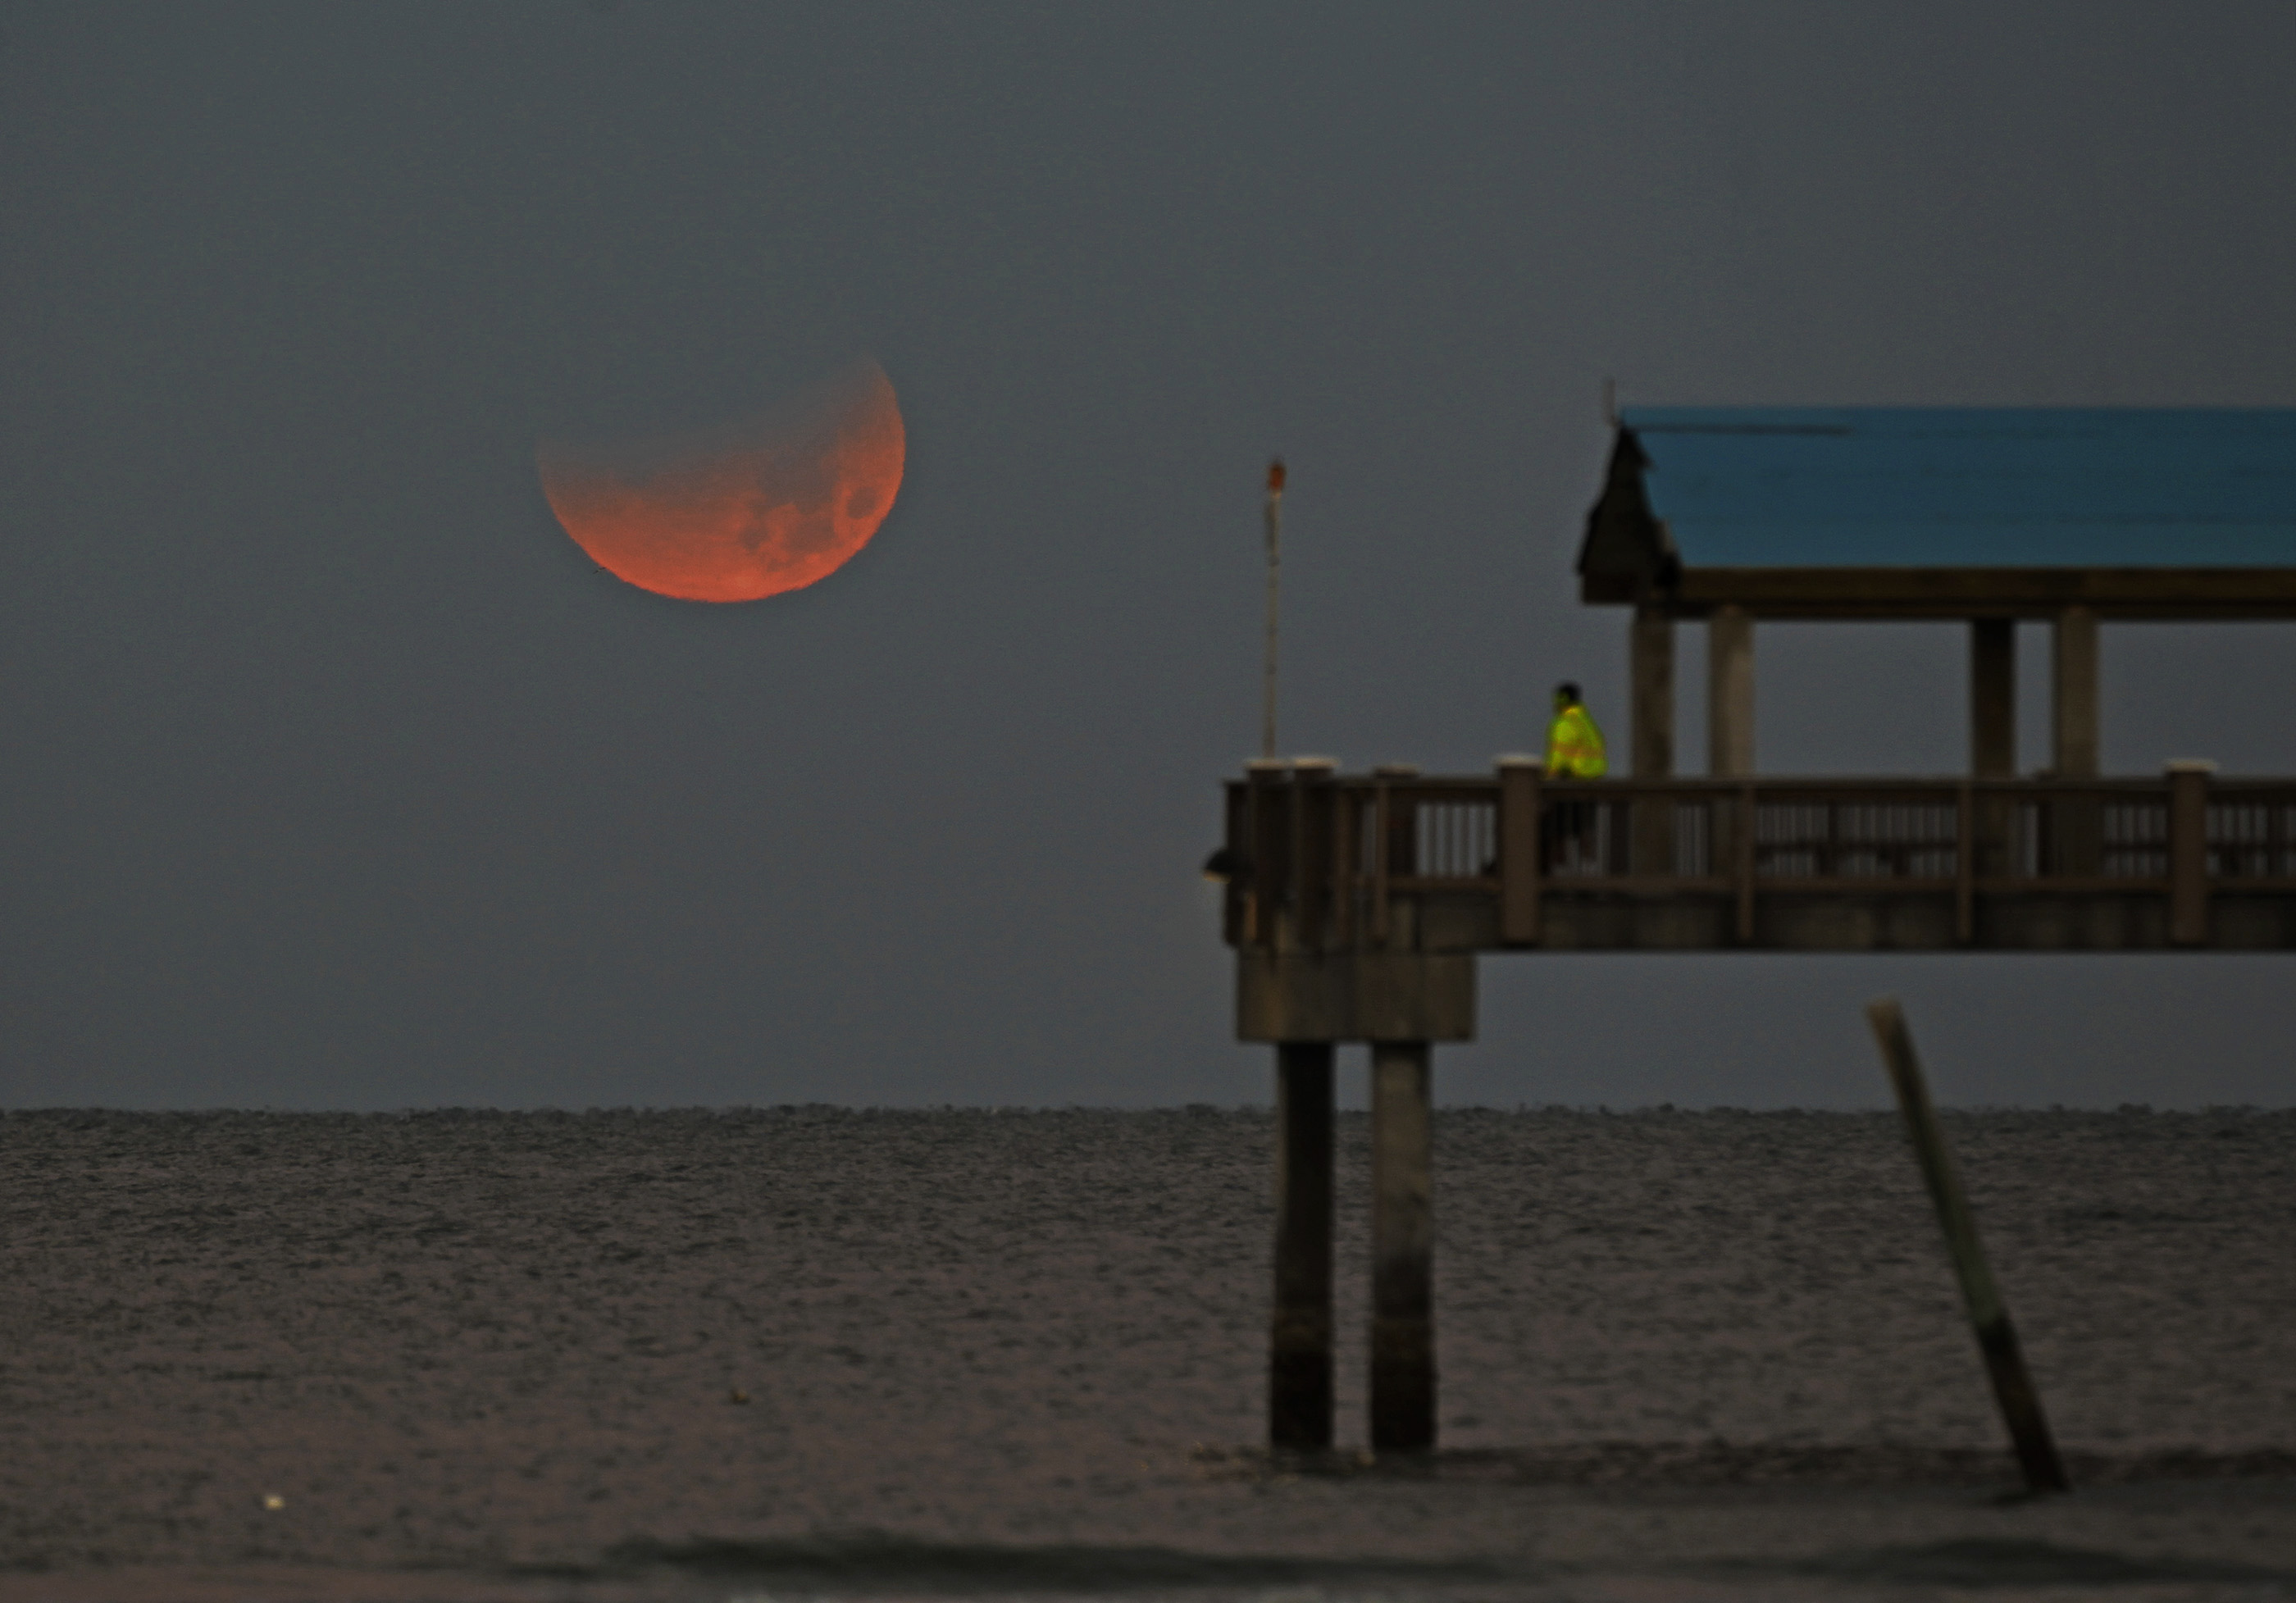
[1371,1041,1435,1454]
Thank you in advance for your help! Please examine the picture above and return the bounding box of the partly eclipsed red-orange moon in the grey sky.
[535,363,909,602]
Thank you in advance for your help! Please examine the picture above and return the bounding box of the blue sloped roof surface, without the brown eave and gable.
[1621,407,2296,567]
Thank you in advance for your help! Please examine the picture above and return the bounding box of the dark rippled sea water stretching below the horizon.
[0,1109,2296,1598]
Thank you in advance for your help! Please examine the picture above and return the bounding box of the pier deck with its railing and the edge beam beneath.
[1226,763,2296,953]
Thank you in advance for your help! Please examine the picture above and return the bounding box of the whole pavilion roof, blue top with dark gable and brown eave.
[1579,407,2296,617]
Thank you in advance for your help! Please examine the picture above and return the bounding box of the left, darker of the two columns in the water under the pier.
[1268,1041,1332,1449]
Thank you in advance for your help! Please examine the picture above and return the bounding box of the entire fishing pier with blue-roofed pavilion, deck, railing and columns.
[1212,409,2296,1451]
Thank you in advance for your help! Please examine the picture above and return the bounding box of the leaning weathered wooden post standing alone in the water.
[1866,997,2069,1493]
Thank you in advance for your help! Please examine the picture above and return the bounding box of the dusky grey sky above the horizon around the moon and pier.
[0,0,2296,1107]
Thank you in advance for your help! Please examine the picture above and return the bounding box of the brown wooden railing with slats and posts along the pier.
[1223,763,2296,949]
